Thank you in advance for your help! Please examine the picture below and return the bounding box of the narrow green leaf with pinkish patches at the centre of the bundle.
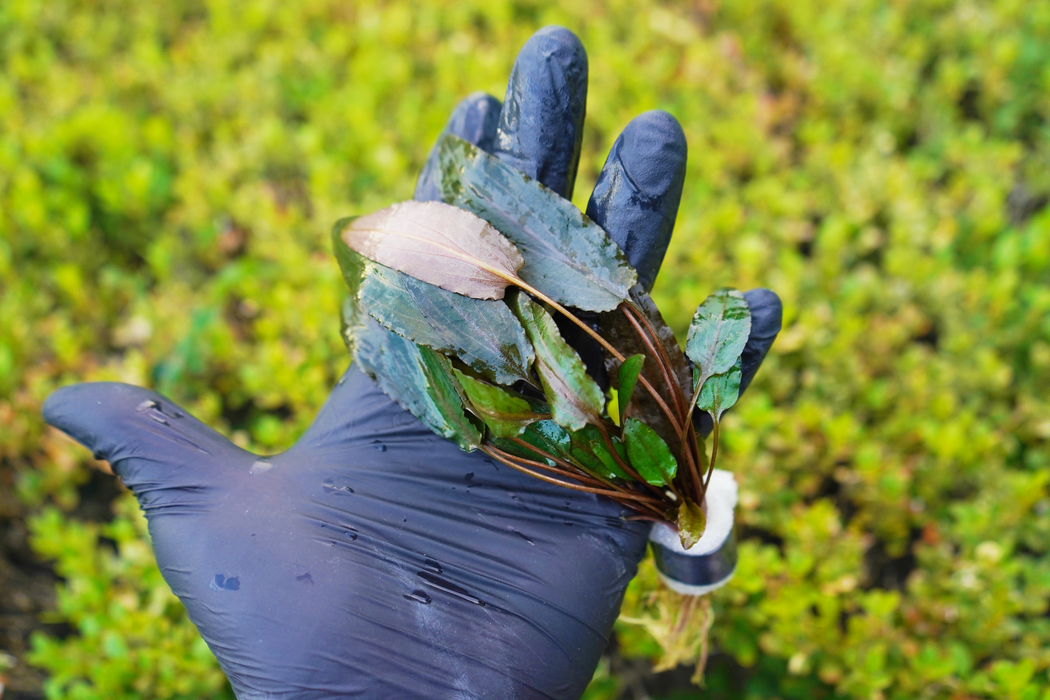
[507,292,603,430]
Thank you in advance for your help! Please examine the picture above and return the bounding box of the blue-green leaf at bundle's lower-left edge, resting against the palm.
[342,297,481,452]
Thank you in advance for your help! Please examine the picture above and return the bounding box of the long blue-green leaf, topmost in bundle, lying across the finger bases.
[437,133,637,311]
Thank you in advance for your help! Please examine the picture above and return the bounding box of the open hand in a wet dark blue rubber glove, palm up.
[44,28,779,700]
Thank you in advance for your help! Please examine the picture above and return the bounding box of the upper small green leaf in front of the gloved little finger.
[686,290,751,385]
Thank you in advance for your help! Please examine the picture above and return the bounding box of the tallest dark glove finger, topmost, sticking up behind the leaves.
[495,26,587,199]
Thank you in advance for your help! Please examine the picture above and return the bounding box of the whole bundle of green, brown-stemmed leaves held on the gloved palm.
[333,134,751,548]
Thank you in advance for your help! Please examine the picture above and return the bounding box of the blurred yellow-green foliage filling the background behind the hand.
[0,0,1050,700]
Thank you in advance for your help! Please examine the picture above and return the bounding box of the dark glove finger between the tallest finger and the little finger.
[587,111,687,291]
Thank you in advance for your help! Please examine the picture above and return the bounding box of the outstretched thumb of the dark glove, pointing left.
[43,382,256,503]
